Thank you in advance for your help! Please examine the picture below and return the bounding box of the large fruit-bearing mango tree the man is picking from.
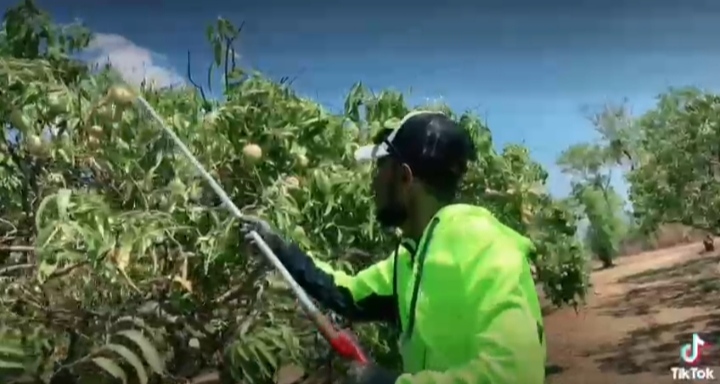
[0,1,586,384]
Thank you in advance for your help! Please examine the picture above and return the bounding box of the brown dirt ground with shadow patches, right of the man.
[545,241,720,384]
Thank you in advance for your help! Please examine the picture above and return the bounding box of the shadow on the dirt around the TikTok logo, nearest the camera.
[588,314,720,375]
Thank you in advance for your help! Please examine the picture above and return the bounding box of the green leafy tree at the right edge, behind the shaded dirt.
[628,89,720,240]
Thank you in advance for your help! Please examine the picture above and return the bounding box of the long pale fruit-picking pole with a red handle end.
[137,96,369,364]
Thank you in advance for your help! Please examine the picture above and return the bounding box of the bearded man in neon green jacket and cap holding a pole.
[243,112,545,384]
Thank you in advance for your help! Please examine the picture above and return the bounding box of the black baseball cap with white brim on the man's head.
[355,111,477,181]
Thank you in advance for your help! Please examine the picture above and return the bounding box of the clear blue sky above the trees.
[16,0,720,198]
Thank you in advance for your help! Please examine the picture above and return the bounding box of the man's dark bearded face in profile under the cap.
[372,156,412,227]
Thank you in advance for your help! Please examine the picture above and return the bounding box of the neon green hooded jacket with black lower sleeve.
[284,204,546,384]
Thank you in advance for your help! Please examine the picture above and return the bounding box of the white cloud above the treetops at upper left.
[83,33,185,87]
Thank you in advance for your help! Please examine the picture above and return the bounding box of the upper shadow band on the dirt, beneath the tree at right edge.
[597,257,720,317]
